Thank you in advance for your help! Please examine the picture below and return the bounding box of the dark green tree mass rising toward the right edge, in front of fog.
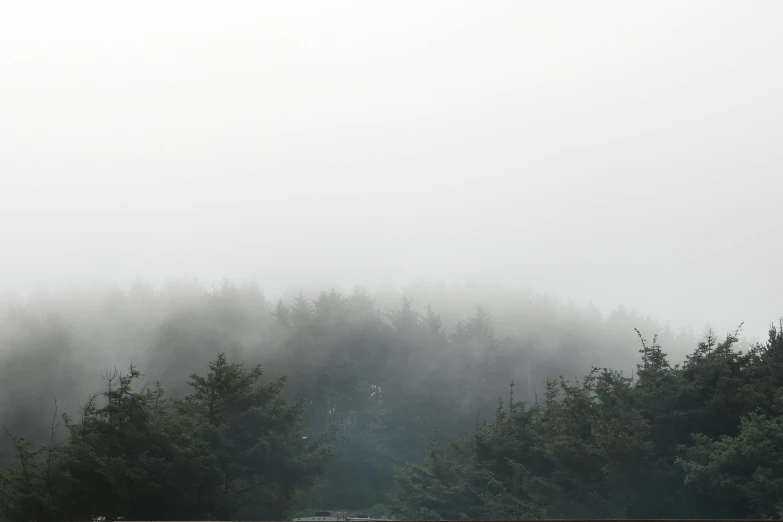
[391,318,783,520]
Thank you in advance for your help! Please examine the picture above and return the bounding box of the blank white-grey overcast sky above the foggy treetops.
[0,0,783,334]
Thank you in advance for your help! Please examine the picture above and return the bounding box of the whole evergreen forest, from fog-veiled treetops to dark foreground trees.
[0,280,783,522]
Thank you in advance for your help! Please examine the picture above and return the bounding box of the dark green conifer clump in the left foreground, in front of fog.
[0,354,331,520]
